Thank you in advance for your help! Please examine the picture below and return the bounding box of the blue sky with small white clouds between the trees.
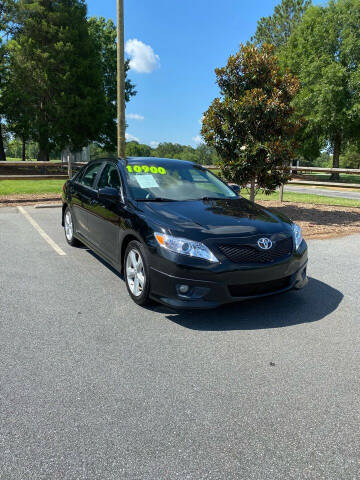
[88,0,318,146]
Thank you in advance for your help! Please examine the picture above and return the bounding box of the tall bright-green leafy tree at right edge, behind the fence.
[281,0,360,180]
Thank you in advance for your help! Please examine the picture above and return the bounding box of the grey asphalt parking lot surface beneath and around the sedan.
[0,207,360,480]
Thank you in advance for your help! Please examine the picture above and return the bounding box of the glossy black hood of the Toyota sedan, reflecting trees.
[140,198,291,238]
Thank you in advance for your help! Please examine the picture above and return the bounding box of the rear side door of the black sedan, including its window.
[72,162,103,241]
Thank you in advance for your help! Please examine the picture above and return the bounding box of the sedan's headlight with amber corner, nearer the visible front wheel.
[154,233,219,262]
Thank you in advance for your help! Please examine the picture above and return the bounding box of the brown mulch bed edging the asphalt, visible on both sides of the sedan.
[0,194,360,239]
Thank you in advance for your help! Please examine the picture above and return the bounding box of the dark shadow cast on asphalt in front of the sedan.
[160,278,344,331]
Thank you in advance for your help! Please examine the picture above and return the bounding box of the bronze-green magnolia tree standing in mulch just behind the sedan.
[201,44,299,201]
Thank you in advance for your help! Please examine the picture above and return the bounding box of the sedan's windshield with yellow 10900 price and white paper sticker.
[126,160,237,201]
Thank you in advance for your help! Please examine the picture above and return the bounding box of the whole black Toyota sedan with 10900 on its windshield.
[62,158,307,308]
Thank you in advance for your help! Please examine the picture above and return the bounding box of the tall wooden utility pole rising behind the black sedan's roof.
[117,0,126,159]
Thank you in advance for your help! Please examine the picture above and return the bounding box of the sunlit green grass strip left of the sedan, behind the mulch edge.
[0,180,65,197]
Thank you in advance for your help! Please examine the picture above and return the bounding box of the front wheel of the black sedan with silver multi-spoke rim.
[124,240,152,307]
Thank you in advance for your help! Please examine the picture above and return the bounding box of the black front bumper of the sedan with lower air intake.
[150,243,308,309]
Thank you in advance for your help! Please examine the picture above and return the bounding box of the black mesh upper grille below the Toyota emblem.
[218,237,293,264]
